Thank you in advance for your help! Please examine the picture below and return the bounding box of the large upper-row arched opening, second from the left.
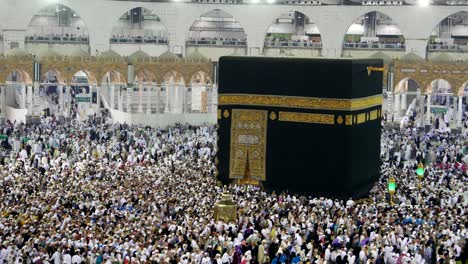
[110,7,169,56]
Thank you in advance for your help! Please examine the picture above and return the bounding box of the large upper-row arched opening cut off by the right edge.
[428,11,468,52]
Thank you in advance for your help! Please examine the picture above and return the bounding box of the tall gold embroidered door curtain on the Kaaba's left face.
[229,109,268,184]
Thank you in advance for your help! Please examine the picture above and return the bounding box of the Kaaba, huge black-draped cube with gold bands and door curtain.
[216,56,383,199]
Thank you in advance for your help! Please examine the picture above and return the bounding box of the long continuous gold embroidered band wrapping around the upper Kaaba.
[218,94,383,111]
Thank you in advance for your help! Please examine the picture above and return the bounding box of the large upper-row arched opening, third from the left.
[186,9,247,47]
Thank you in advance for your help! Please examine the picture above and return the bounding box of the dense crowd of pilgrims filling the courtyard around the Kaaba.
[0,119,468,264]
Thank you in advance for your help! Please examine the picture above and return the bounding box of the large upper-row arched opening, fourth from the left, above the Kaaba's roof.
[265,11,322,49]
